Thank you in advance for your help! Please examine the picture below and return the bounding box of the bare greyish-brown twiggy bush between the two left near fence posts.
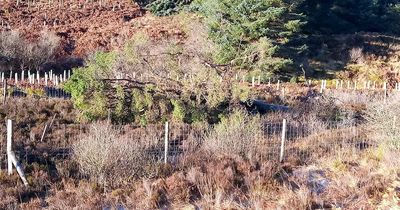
[73,123,156,186]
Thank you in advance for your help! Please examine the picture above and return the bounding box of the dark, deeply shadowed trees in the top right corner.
[299,0,400,34]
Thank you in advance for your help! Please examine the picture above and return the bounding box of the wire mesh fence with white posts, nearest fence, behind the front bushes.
[0,118,376,169]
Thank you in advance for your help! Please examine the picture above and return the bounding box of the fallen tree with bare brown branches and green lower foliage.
[65,30,253,124]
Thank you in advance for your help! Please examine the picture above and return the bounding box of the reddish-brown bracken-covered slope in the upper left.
[0,1,184,58]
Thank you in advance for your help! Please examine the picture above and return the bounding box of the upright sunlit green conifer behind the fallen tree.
[193,0,303,72]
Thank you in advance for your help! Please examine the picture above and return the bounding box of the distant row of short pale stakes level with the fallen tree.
[0,70,400,101]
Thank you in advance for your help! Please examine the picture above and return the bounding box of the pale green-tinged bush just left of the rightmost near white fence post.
[204,110,267,160]
